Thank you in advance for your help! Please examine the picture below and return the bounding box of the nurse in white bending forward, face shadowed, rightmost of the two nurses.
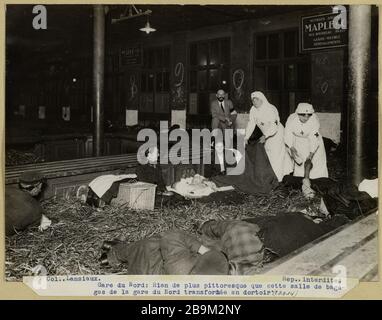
[284,103,328,179]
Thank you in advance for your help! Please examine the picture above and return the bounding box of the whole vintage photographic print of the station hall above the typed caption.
[3,3,379,282]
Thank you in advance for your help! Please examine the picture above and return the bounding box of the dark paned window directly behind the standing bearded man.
[188,38,231,114]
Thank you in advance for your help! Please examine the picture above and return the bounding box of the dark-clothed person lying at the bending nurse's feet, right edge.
[281,176,378,220]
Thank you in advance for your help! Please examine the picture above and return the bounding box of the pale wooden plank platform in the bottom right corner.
[261,213,378,281]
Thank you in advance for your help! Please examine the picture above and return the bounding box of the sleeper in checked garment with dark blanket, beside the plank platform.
[199,212,349,275]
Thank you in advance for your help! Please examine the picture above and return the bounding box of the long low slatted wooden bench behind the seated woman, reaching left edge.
[5,150,211,199]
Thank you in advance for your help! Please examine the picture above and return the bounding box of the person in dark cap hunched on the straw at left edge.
[5,171,51,236]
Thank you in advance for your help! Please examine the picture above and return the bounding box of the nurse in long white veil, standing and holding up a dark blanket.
[245,91,292,182]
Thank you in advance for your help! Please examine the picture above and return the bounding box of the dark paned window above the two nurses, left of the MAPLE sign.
[253,30,311,121]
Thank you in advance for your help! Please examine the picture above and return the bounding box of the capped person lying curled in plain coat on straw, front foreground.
[100,229,229,275]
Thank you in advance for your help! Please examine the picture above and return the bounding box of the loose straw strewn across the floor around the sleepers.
[6,191,314,281]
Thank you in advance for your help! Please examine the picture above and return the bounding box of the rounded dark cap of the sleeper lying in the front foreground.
[190,250,229,275]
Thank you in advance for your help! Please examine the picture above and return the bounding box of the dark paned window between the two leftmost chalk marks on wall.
[140,47,170,113]
